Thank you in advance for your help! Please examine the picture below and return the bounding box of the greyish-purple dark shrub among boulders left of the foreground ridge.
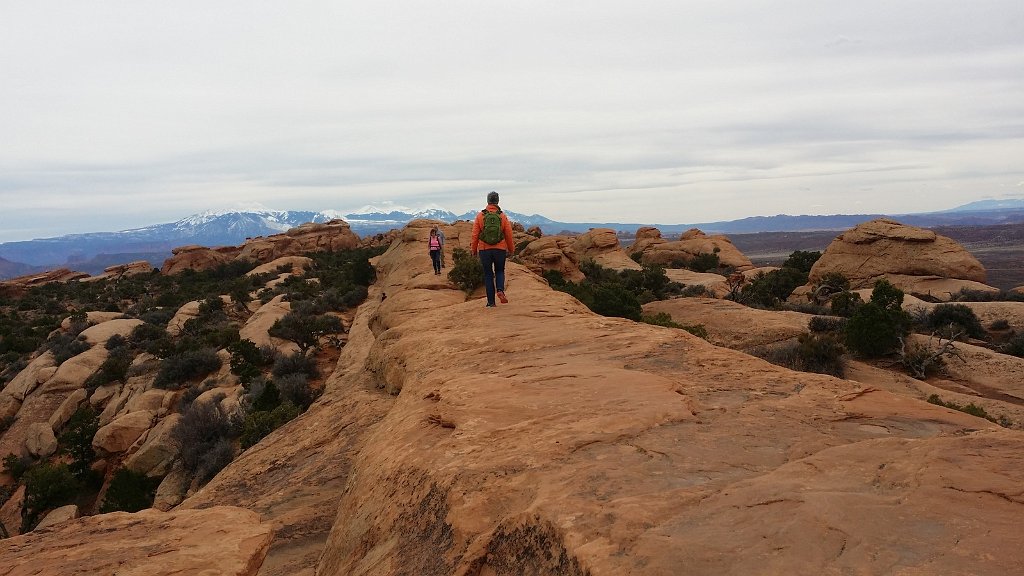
[171,393,237,483]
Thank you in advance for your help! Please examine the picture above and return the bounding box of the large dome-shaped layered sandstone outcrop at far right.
[809,218,997,299]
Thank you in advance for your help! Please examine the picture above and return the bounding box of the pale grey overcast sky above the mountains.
[0,0,1024,242]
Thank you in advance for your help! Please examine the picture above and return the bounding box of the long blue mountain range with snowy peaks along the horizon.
[0,199,1024,279]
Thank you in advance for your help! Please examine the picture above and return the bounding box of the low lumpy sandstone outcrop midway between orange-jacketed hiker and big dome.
[629,227,754,272]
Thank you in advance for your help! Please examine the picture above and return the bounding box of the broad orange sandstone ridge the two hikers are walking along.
[184,217,1024,575]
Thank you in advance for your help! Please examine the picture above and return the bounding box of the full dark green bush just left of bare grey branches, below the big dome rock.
[846,280,910,358]
